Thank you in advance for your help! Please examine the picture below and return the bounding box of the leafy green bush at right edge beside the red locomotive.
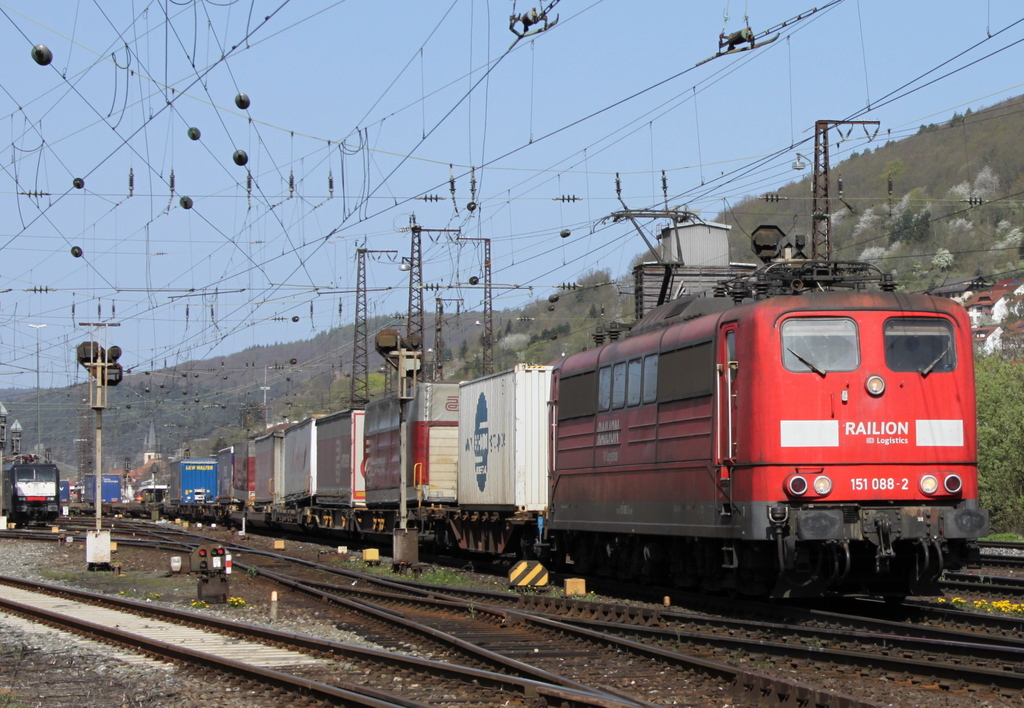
[975,357,1024,534]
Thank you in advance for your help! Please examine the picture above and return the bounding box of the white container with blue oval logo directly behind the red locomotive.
[459,364,551,511]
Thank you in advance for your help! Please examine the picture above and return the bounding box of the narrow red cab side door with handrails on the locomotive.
[715,322,739,516]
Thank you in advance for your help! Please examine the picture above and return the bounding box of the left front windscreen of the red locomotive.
[782,318,860,376]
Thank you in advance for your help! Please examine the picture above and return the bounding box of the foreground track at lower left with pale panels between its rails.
[0,577,639,708]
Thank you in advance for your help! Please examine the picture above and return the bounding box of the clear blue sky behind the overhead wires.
[0,0,1024,387]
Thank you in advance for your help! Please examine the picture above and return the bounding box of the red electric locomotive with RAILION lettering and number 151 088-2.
[545,252,988,597]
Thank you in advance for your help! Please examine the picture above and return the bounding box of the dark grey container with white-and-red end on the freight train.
[316,410,367,507]
